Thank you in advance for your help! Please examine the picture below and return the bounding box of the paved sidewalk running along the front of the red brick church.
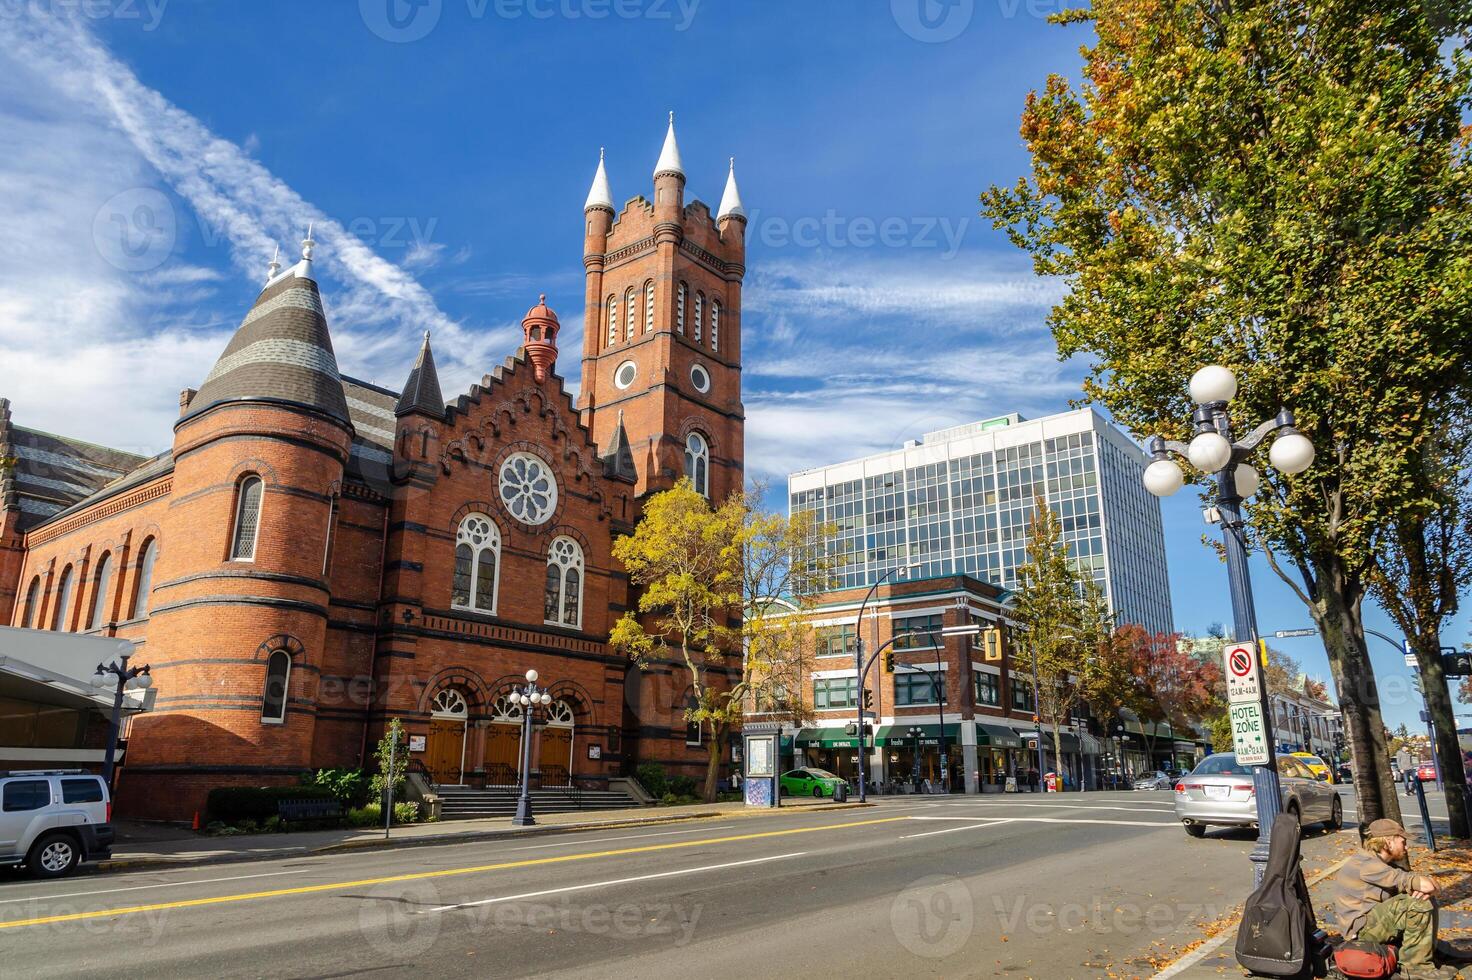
[99,800,873,871]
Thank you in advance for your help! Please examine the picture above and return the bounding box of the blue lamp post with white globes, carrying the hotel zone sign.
[1145,365,1313,883]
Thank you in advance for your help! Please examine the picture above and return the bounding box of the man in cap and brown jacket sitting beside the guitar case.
[1334,820,1462,980]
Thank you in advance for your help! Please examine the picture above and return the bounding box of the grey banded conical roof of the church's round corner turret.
[185,259,349,422]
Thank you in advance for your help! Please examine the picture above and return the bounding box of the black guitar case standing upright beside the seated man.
[1236,814,1319,977]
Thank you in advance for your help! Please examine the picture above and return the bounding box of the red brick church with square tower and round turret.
[0,119,746,818]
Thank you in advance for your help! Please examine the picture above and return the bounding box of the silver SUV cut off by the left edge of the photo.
[0,770,113,878]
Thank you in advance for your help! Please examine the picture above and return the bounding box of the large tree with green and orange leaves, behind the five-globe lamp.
[982,0,1472,820]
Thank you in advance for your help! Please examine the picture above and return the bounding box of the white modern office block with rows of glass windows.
[788,408,1173,633]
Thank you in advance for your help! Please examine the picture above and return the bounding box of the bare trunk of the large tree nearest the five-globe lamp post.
[1310,559,1400,827]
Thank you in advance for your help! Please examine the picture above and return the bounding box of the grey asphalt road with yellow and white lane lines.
[0,792,1353,979]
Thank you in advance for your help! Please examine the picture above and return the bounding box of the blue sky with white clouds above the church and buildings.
[0,0,1466,724]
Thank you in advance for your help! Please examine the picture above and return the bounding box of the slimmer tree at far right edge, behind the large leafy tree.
[1370,405,1472,839]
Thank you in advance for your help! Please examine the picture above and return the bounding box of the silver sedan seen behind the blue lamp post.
[1176,752,1344,837]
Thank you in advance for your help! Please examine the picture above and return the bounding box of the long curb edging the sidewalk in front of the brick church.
[97,802,874,874]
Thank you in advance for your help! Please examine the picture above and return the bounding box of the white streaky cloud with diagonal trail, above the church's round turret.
[0,7,518,441]
